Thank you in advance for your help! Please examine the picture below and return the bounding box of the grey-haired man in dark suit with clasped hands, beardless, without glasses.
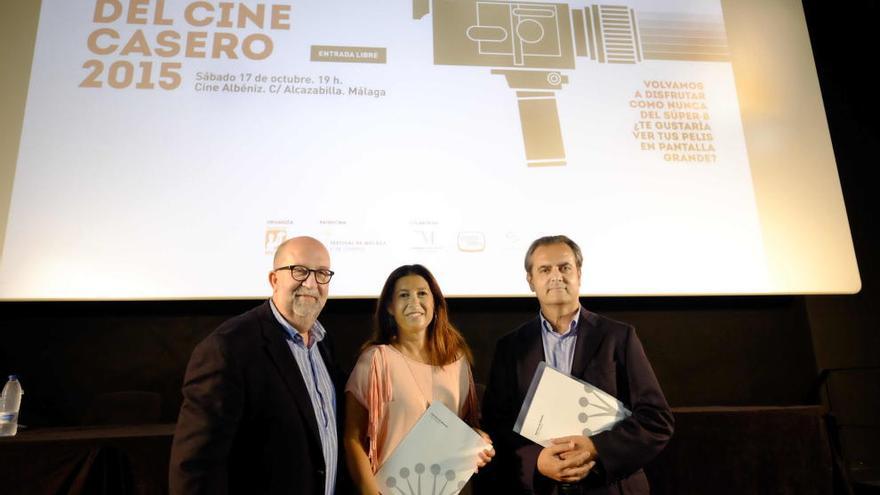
[481,236,673,494]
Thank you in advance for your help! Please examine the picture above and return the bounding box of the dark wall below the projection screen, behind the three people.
[0,297,817,426]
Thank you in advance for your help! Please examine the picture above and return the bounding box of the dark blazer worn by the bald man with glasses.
[169,301,347,495]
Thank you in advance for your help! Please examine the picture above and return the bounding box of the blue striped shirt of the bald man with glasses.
[269,299,339,495]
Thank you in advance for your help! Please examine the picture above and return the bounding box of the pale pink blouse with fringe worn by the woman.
[345,345,472,473]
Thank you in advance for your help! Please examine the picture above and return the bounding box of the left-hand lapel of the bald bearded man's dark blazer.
[259,302,321,448]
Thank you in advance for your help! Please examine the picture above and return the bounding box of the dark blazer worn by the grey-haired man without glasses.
[480,309,673,494]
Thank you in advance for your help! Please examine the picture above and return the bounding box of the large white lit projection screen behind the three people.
[0,0,861,300]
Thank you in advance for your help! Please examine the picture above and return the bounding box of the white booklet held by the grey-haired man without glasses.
[513,361,632,447]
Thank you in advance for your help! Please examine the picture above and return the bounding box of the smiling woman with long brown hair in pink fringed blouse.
[343,265,494,495]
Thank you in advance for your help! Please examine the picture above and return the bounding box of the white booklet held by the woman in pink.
[375,401,489,495]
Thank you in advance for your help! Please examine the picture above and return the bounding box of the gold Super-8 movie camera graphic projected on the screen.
[413,0,730,167]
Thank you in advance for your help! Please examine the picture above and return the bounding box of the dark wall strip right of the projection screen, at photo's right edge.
[804,0,880,483]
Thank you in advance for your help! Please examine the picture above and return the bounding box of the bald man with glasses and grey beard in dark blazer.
[169,237,346,495]
